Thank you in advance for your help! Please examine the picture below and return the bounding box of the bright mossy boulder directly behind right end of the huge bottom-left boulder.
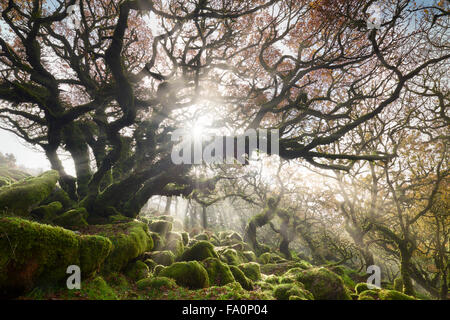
[79,221,153,273]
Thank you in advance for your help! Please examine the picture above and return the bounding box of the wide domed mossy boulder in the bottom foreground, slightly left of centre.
[158,261,209,289]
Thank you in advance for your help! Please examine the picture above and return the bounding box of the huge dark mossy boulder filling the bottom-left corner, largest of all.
[0,217,112,296]
